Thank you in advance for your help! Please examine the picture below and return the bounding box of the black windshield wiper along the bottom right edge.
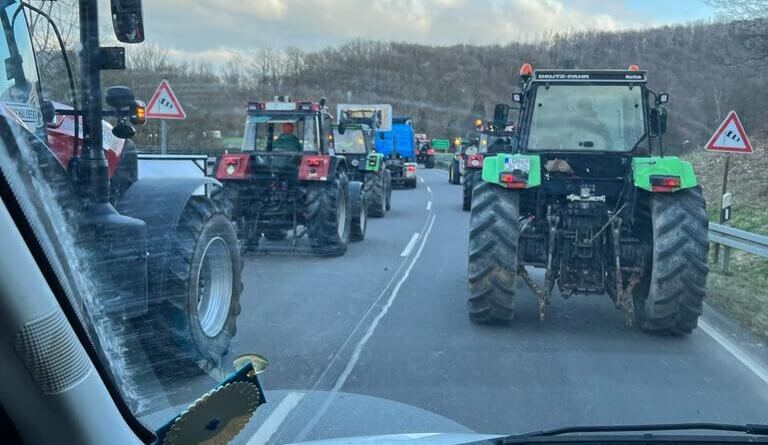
[503,423,768,443]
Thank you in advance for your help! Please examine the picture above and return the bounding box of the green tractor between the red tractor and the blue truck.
[333,118,392,218]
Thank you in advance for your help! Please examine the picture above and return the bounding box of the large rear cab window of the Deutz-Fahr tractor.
[528,85,645,152]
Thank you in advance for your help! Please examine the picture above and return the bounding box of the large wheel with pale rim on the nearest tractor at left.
[155,197,243,372]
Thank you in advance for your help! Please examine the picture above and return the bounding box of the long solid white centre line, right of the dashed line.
[293,215,437,442]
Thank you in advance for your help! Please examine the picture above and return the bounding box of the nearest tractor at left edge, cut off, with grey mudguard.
[0,0,243,410]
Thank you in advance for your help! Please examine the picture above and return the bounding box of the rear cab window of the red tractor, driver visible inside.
[242,115,317,152]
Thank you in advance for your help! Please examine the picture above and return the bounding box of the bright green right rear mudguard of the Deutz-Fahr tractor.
[632,156,698,192]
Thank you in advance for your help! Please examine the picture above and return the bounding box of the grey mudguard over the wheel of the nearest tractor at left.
[117,177,221,298]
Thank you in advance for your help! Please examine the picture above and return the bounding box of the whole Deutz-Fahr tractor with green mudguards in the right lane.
[468,64,708,335]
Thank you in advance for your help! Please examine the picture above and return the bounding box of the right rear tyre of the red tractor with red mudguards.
[306,172,352,256]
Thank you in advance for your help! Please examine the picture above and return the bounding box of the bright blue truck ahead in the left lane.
[375,116,417,188]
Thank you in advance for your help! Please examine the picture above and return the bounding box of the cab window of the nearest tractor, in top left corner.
[0,2,43,129]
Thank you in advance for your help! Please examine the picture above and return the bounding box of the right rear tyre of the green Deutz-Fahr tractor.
[636,188,709,335]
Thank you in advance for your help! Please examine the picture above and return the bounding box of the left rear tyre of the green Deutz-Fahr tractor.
[467,182,520,323]
